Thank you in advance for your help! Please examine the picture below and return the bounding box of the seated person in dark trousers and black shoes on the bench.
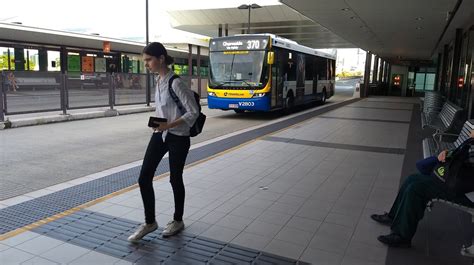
[370,130,474,247]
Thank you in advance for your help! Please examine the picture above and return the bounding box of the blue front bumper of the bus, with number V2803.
[207,95,270,111]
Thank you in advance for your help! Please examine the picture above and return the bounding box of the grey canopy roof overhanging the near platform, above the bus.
[168,0,474,64]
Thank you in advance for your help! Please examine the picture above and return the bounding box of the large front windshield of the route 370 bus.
[209,50,266,88]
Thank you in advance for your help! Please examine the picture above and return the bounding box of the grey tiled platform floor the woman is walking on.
[0,97,474,265]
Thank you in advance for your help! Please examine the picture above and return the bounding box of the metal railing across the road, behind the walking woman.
[0,71,207,122]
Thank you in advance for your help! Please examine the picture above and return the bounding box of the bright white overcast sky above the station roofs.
[0,0,280,41]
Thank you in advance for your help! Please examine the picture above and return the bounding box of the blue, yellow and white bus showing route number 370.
[207,34,336,113]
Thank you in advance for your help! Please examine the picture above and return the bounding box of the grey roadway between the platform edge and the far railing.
[0,82,353,200]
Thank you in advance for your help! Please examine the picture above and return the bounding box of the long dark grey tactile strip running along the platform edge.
[0,99,357,235]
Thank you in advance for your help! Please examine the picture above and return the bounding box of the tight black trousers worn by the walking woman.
[138,133,191,224]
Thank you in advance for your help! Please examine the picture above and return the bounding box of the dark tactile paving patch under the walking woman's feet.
[32,210,307,265]
